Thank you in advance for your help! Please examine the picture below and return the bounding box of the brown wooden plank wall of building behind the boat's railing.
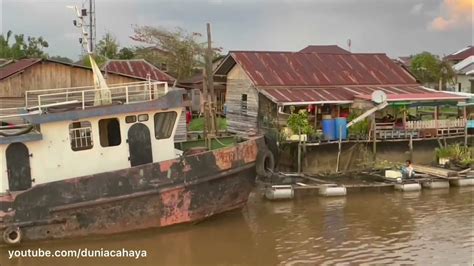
[0,61,141,98]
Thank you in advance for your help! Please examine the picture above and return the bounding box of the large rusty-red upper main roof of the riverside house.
[230,52,417,86]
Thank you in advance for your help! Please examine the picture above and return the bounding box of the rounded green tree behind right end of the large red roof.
[411,52,455,88]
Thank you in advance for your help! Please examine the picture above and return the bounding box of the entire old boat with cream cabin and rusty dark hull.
[0,78,272,244]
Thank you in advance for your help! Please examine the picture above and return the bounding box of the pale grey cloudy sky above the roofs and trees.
[0,0,474,59]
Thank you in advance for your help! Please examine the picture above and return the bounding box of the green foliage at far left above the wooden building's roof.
[0,30,49,59]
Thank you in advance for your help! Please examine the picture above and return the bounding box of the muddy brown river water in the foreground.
[0,188,474,266]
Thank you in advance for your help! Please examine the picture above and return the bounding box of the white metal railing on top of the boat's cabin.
[25,81,168,111]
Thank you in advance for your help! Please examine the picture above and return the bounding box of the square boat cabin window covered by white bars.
[69,121,94,151]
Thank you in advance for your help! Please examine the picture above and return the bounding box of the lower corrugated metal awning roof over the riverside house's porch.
[258,86,468,105]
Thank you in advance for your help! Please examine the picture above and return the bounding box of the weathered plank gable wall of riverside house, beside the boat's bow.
[225,65,258,135]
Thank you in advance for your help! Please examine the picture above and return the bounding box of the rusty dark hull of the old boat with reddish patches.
[0,137,265,242]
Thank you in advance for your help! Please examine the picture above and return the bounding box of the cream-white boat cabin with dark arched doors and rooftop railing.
[0,82,185,193]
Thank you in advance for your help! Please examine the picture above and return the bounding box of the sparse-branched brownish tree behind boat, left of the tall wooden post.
[131,26,219,80]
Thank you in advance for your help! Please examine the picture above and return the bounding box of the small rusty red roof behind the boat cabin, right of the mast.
[102,59,175,83]
